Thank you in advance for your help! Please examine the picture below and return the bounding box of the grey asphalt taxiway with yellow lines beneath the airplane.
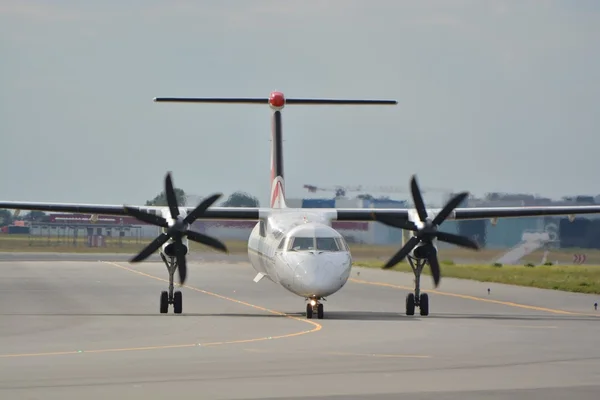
[0,253,600,400]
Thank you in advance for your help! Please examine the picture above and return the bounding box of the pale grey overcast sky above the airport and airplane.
[0,0,600,205]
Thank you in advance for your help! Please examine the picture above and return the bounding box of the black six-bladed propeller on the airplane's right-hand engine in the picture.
[375,175,479,287]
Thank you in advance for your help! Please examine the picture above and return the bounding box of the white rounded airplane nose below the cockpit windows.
[286,252,351,297]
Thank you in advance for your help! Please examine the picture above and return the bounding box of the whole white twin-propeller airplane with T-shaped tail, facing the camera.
[0,92,600,319]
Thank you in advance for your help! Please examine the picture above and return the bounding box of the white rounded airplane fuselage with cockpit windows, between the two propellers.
[248,209,352,299]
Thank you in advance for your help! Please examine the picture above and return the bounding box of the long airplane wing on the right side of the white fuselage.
[334,206,600,221]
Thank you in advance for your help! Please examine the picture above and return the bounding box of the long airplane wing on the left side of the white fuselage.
[0,201,268,220]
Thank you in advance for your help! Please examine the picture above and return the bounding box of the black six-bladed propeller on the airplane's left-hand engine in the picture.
[123,173,227,285]
